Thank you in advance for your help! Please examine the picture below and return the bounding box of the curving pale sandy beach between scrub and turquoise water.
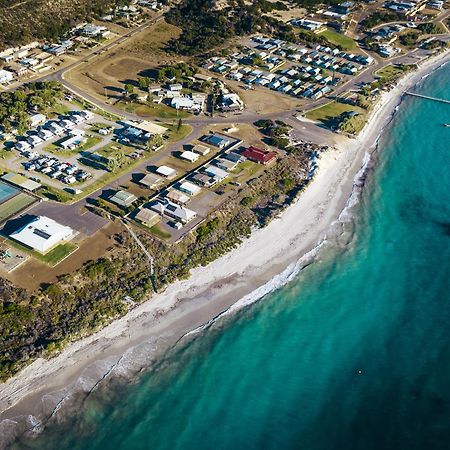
[0,51,450,448]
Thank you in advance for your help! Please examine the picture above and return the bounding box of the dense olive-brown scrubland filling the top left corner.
[0,0,128,50]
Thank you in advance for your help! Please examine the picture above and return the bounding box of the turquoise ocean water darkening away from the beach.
[14,61,450,450]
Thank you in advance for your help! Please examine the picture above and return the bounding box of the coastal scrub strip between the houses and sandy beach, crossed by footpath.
[0,152,314,380]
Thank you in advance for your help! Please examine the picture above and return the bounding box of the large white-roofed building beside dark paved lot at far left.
[10,216,75,253]
